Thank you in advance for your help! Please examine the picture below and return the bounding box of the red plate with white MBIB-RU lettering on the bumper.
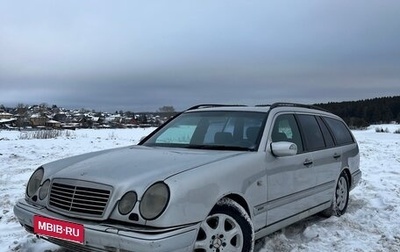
[33,215,85,244]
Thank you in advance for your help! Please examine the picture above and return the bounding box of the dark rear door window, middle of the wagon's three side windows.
[297,115,325,151]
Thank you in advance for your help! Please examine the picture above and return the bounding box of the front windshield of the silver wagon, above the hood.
[142,111,267,151]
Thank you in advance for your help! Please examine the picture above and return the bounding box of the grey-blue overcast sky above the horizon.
[0,0,400,111]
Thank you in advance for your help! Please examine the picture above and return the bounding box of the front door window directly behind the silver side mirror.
[271,114,303,153]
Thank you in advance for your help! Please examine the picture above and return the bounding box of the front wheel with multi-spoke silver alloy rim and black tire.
[194,198,254,252]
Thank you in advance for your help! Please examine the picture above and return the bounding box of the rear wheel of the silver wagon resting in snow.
[321,172,350,217]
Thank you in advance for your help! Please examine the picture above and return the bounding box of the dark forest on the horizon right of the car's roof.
[315,96,400,128]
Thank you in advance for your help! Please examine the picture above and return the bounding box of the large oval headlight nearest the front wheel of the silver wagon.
[140,182,169,220]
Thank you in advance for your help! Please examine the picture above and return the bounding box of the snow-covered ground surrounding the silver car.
[0,125,400,252]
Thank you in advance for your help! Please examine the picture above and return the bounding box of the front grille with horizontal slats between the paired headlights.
[49,181,111,218]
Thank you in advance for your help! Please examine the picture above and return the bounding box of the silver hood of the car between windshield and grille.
[43,146,243,193]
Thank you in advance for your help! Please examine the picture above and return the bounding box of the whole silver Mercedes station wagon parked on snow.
[14,103,361,252]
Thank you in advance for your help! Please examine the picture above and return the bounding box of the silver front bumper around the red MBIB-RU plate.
[14,199,200,252]
